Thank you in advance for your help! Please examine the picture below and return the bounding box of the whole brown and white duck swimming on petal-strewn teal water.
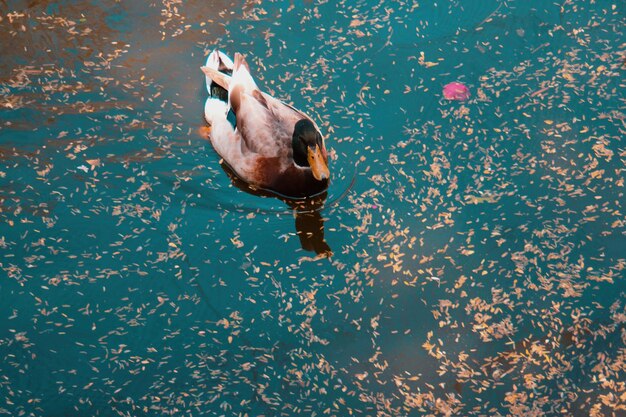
[202,50,330,197]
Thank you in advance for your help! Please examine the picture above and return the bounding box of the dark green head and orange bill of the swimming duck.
[291,119,330,181]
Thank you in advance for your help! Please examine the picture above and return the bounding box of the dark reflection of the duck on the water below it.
[220,162,332,257]
